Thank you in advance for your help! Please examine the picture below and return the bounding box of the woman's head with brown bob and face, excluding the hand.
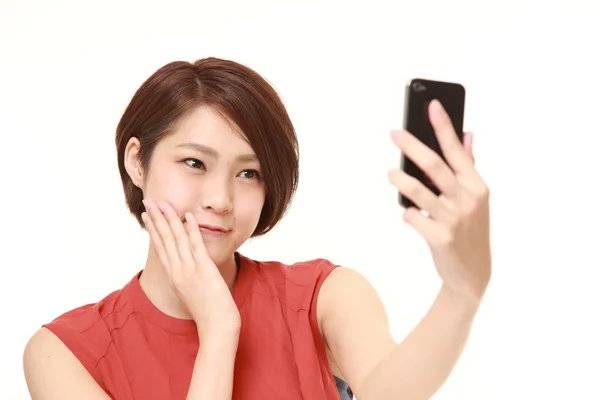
[116,58,298,261]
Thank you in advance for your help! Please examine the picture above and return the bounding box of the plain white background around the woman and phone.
[0,0,600,400]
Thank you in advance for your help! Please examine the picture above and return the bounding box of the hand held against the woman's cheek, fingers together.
[142,199,241,336]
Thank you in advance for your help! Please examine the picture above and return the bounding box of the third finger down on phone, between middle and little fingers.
[388,170,450,223]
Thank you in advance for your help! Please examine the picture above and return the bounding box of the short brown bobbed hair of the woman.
[116,57,299,236]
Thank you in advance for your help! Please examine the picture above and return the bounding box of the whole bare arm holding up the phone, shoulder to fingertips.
[317,100,492,400]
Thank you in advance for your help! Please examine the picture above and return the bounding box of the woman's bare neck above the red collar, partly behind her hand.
[139,245,238,319]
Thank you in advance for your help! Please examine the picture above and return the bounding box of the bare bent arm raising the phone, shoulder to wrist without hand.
[317,268,478,400]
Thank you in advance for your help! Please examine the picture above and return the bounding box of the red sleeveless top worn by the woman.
[44,254,339,400]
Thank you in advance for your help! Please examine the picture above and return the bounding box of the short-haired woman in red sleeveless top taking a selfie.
[24,58,491,400]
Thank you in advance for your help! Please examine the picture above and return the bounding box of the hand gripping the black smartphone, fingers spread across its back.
[389,100,492,303]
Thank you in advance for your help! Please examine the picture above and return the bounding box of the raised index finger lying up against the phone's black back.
[429,100,475,175]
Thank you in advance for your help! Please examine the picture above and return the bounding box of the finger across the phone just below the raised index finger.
[391,131,460,197]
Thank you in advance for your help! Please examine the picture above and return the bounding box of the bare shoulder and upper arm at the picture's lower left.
[23,328,109,400]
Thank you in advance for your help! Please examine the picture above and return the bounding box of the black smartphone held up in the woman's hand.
[398,79,465,208]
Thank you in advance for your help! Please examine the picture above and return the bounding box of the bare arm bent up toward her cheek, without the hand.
[23,328,238,400]
